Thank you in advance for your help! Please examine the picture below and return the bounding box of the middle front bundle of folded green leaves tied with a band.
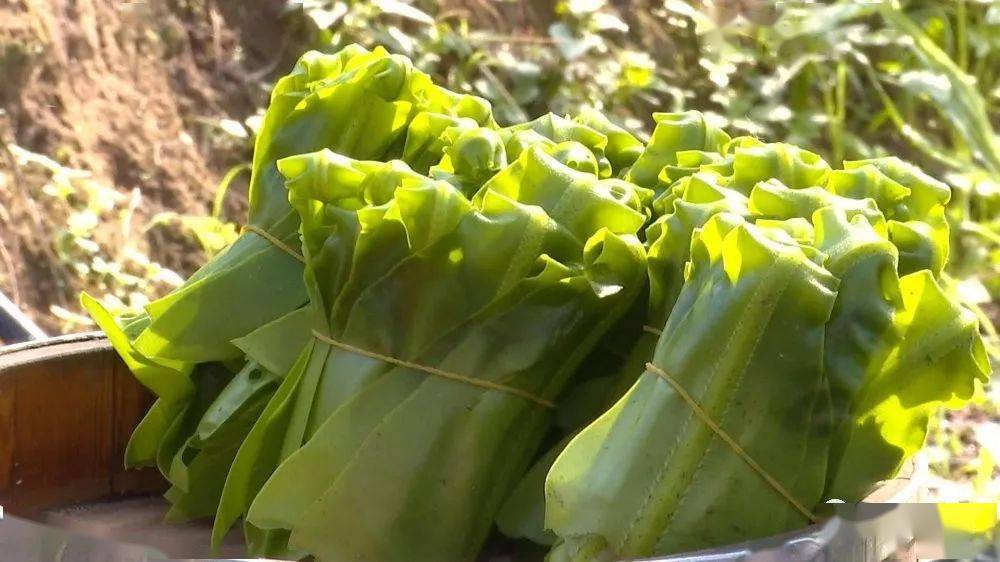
[247,150,644,560]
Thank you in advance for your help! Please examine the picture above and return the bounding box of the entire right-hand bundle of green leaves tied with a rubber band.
[545,121,989,561]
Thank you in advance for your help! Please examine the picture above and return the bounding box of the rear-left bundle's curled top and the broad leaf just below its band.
[129,46,492,362]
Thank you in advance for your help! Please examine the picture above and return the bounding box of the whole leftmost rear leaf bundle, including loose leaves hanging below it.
[83,46,493,520]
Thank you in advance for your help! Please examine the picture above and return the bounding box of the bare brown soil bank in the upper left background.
[0,0,300,331]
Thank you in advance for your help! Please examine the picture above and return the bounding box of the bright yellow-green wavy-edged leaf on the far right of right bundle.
[827,271,990,500]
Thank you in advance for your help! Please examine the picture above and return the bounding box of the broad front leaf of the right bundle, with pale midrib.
[545,215,837,561]
